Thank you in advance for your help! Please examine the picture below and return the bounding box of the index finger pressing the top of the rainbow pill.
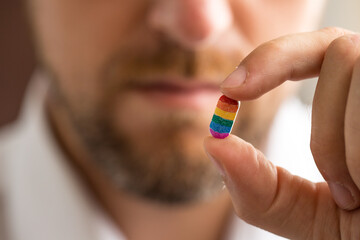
[221,28,351,101]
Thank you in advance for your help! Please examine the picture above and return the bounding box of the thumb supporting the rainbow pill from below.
[204,135,336,239]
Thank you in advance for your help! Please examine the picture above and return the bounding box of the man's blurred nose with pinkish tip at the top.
[149,0,233,48]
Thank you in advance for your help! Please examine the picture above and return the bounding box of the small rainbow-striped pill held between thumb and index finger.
[210,95,239,139]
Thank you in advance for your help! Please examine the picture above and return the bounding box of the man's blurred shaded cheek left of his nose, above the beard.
[31,0,148,103]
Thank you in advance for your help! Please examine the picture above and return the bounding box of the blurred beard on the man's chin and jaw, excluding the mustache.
[69,104,223,204]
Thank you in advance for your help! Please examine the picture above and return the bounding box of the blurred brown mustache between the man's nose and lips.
[105,40,243,86]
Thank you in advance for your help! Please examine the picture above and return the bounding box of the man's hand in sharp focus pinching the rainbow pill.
[205,28,360,240]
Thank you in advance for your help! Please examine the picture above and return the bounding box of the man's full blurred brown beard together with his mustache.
[44,34,246,204]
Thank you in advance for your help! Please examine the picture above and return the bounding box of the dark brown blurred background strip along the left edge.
[0,0,35,126]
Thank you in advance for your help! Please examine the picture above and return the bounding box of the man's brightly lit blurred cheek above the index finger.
[233,0,325,46]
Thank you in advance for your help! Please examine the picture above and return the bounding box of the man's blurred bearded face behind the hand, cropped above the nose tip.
[29,0,323,201]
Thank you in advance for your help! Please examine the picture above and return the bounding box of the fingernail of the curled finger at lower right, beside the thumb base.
[328,182,355,209]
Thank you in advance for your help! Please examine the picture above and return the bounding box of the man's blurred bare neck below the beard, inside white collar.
[48,96,232,240]
